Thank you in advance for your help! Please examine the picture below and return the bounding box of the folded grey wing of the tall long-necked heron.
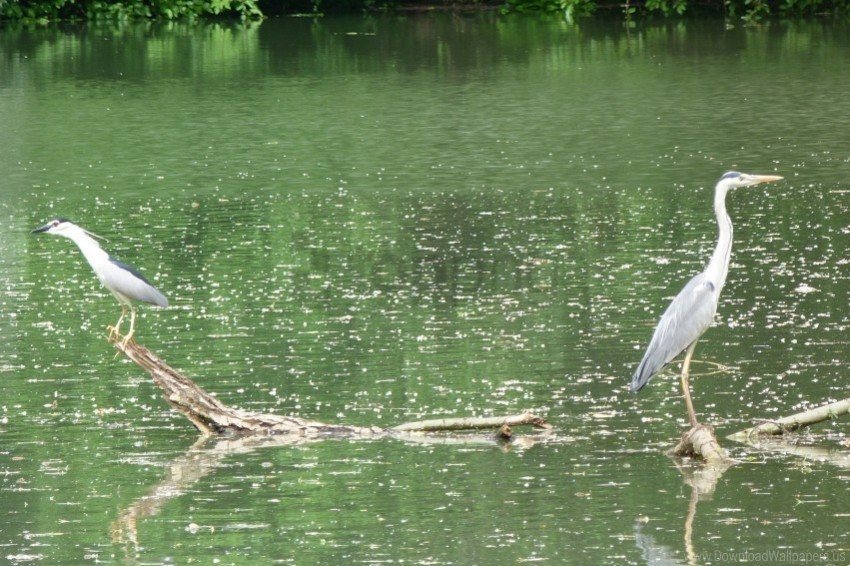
[631,273,717,392]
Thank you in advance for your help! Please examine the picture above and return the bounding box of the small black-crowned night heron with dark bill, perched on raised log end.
[32,218,168,347]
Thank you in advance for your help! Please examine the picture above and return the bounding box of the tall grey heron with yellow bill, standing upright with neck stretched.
[631,171,782,427]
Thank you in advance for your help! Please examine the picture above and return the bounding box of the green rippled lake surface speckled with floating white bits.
[0,14,850,564]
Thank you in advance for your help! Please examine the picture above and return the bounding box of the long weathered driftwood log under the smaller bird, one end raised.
[109,334,551,438]
